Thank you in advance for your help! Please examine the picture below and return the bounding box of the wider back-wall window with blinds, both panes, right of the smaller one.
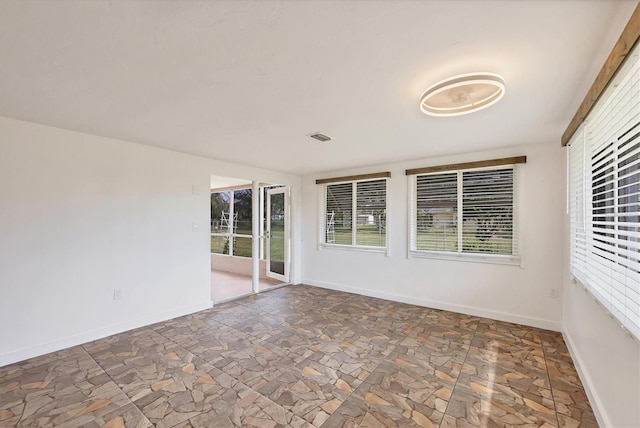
[410,165,519,263]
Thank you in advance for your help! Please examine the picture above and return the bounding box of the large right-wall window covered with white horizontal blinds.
[568,43,640,338]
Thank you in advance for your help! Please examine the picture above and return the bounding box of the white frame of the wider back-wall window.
[407,163,524,267]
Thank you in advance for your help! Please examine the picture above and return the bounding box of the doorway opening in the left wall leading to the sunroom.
[211,176,290,303]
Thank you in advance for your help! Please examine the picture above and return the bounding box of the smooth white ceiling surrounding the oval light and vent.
[0,0,637,174]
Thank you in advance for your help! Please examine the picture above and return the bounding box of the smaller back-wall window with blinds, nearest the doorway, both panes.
[319,178,387,249]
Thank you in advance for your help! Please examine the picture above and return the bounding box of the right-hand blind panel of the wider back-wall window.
[462,168,518,254]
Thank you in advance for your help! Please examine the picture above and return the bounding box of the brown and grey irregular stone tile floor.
[0,286,597,428]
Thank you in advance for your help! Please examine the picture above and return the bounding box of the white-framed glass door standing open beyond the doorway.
[265,187,289,282]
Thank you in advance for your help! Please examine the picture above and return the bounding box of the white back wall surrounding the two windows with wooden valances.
[302,142,565,331]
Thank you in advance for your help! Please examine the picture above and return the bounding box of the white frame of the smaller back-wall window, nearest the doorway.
[317,176,389,257]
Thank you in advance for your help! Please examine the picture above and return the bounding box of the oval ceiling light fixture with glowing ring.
[420,73,505,116]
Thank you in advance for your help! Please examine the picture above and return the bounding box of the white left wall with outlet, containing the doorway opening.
[0,118,300,366]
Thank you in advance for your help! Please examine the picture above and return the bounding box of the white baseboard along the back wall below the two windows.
[303,280,561,332]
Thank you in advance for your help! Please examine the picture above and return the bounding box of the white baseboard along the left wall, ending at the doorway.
[0,301,212,367]
